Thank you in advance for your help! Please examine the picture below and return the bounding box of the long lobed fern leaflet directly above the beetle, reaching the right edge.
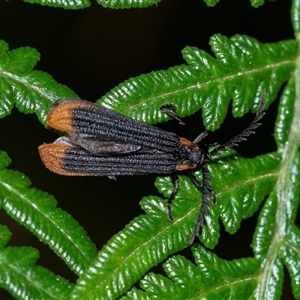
[99,34,297,130]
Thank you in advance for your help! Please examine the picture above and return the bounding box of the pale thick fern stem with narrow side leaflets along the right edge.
[253,78,300,299]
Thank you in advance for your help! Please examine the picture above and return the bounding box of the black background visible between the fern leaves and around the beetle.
[0,0,293,299]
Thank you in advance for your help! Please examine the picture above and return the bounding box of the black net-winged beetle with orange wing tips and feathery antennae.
[39,95,264,244]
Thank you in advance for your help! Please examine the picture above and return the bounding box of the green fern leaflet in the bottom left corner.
[0,226,72,299]
